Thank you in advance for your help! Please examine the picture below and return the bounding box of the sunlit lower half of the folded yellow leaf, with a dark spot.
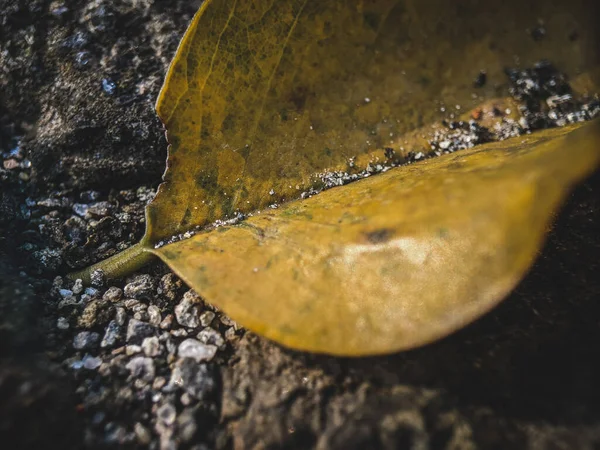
[154,121,600,355]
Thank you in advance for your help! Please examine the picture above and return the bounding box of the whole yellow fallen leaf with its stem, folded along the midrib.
[74,0,598,355]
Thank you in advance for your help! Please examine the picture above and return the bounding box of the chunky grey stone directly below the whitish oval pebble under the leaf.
[169,358,217,401]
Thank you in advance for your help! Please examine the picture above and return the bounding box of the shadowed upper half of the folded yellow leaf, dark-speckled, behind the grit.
[146,0,594,243]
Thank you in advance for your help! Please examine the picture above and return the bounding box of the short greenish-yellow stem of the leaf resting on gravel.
[67,239,154,284]
